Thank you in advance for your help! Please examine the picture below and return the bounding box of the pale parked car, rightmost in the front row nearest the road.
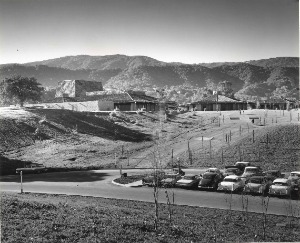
[269,178,299,197]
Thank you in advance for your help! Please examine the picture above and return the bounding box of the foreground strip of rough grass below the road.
[1,193,300,242]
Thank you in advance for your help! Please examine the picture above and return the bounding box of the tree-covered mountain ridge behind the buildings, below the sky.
[0,55,299,96]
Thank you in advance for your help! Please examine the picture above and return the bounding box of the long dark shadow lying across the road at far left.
[0,171,109,182]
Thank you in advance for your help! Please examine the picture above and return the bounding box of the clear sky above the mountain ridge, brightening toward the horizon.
[0,0,299,64]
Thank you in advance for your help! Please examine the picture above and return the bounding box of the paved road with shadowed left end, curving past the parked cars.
[0,169,300,216]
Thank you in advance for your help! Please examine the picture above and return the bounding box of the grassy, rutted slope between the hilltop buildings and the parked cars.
[0,109,300,173]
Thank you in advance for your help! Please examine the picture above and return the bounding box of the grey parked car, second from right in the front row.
[244,176,272,195]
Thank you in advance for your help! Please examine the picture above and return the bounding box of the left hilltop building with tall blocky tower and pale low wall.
[46,80,159,111]
